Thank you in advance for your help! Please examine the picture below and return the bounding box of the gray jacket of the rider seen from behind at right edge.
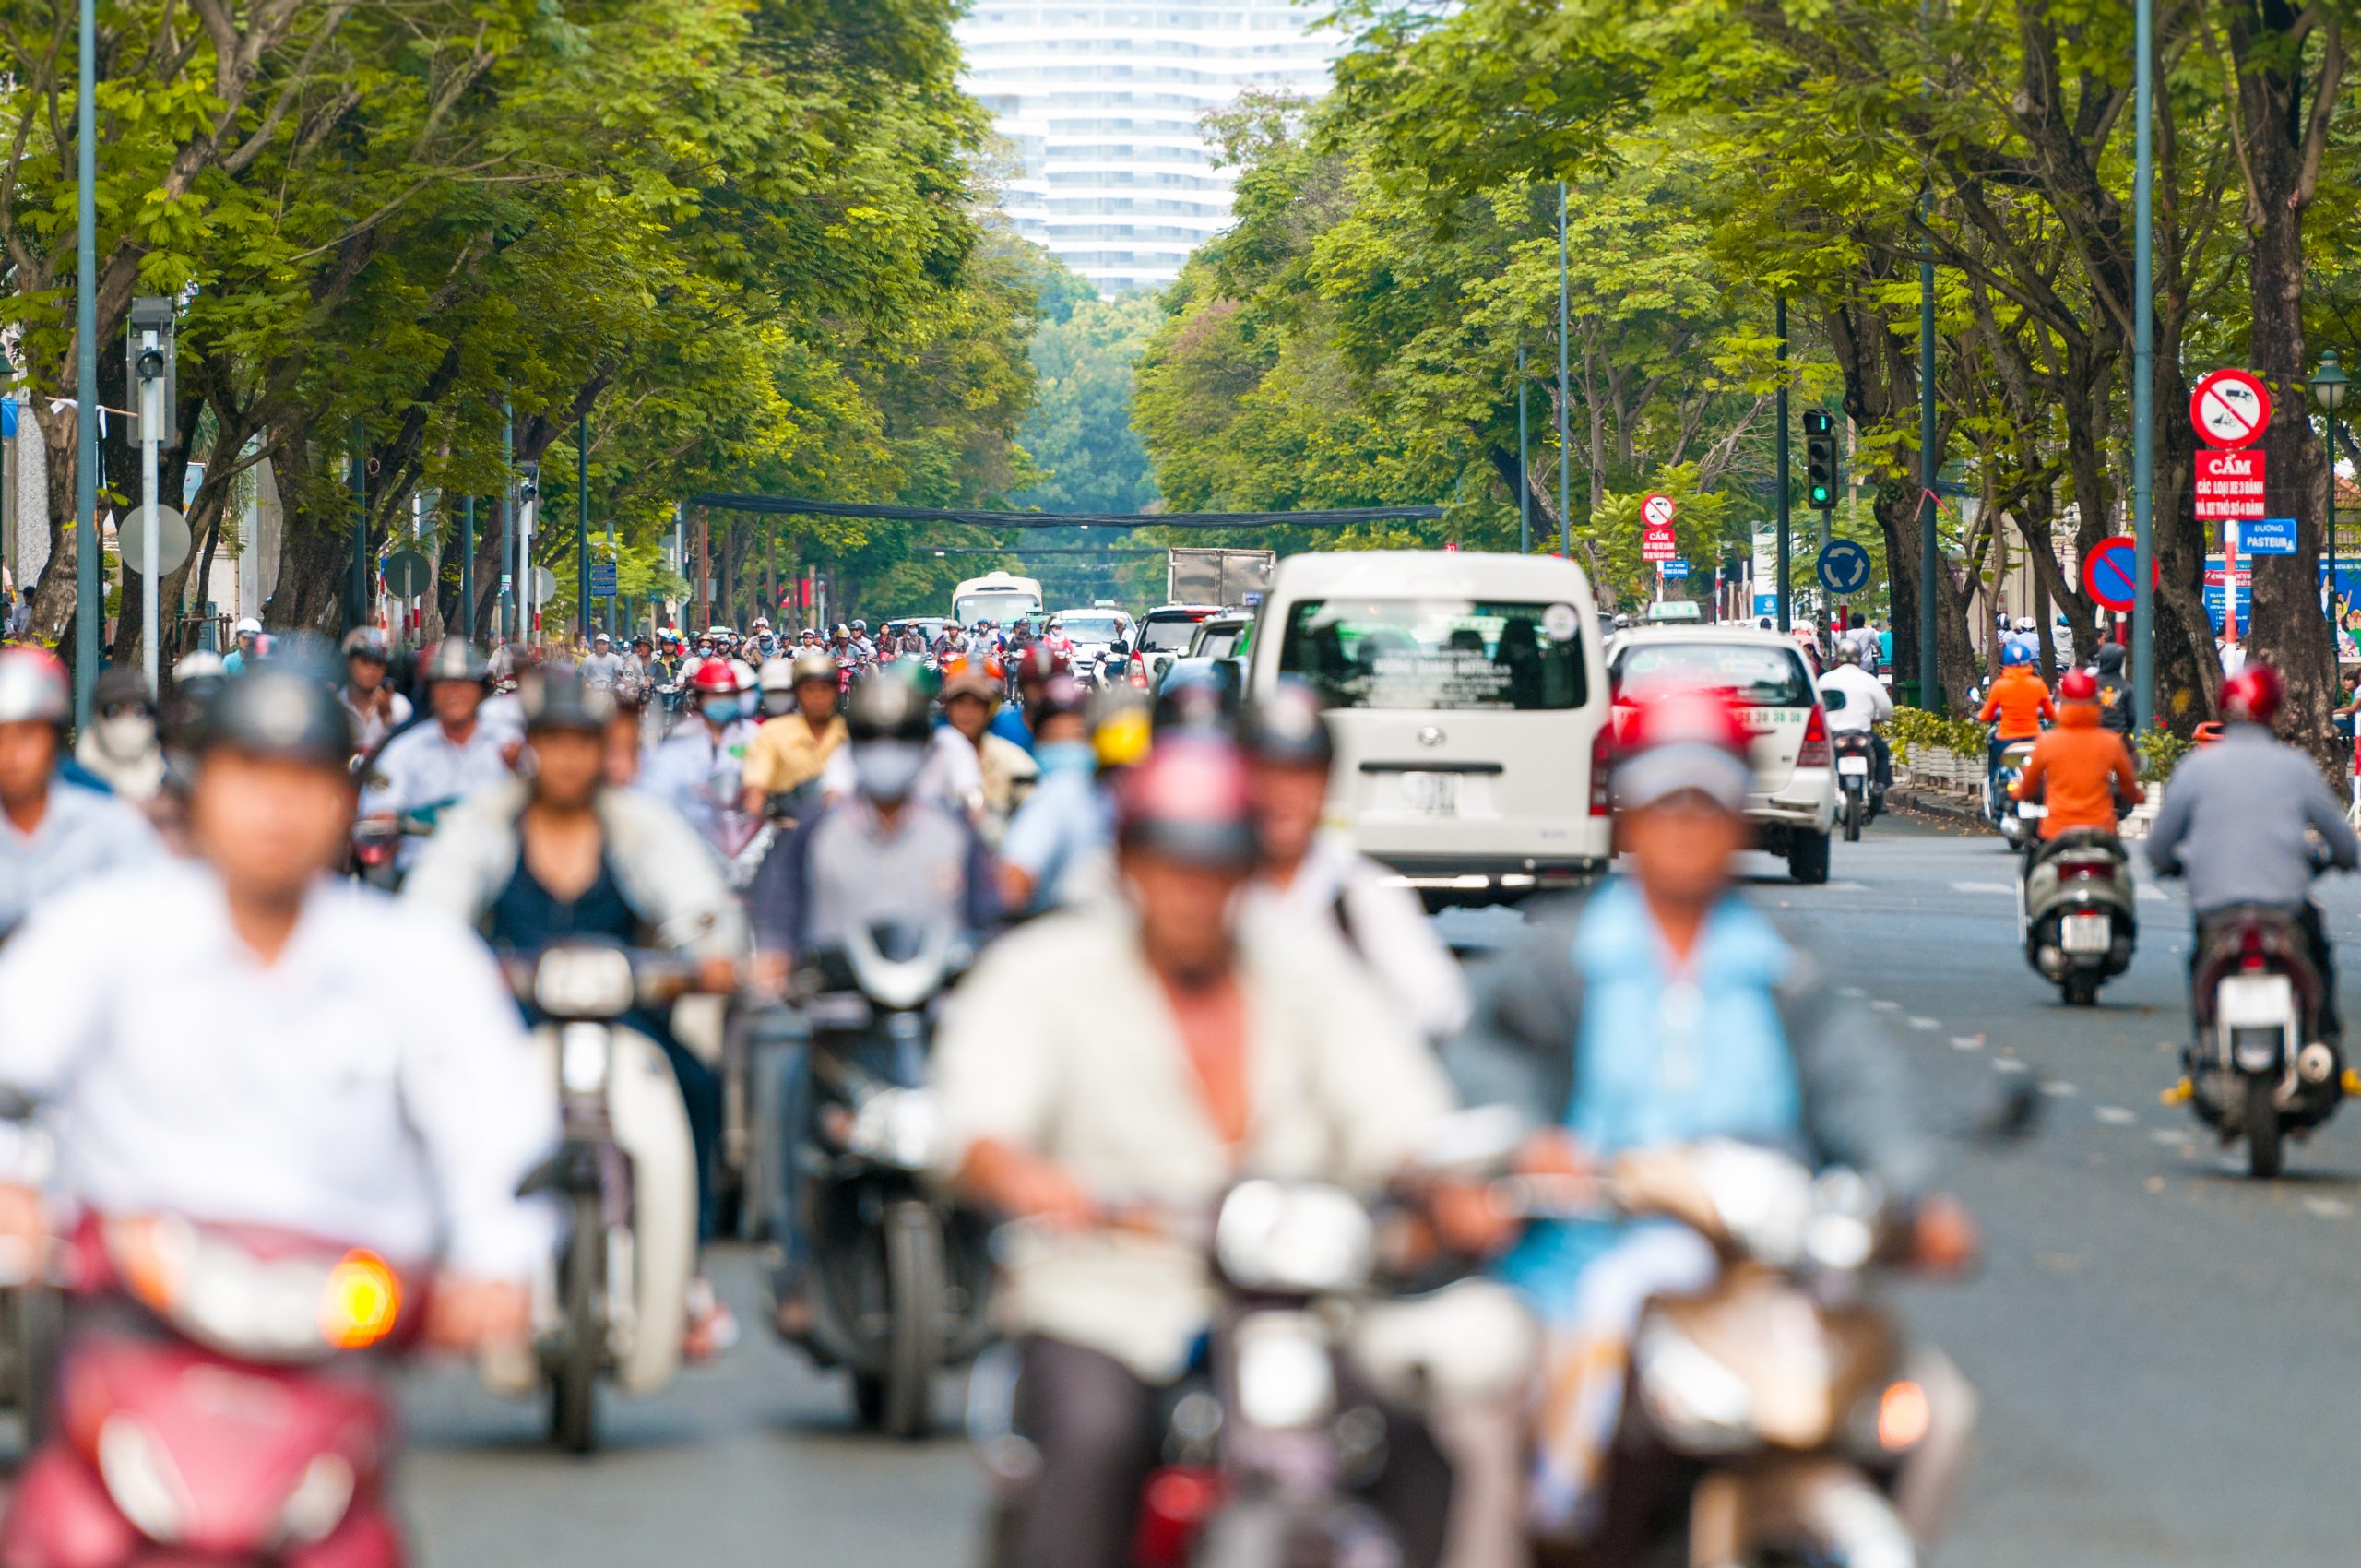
[2149,725,2361,914]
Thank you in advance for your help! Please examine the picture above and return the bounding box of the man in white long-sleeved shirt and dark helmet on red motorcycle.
[0,663,557,1360]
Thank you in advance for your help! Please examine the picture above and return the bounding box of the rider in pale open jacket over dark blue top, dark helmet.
[401,669,746,1356]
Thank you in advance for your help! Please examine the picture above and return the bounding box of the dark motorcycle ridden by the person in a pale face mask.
[760,926,991,1438]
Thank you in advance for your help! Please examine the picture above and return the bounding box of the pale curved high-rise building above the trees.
[958,0,1339,292]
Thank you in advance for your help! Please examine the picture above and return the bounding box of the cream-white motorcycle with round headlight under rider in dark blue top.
[480,943,699,1455]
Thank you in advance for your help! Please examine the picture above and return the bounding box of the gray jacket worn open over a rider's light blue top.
[1442,899,1936,1194]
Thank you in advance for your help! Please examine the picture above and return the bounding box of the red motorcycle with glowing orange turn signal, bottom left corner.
[0,1217,425,1568]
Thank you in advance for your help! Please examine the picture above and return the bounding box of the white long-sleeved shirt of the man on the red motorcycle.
[0,861,557,1280]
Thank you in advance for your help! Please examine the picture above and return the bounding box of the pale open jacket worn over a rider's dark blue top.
[401,779,746,958]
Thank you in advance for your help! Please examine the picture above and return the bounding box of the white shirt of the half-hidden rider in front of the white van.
[1244,834,1471,1039]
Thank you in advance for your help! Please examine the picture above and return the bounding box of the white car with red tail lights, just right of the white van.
[1608,625,1837,884]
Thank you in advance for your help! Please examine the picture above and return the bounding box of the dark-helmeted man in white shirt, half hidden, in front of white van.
[1240,680,1468,1039]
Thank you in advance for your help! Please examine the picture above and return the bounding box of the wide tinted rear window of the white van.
[1280,600,1586,711]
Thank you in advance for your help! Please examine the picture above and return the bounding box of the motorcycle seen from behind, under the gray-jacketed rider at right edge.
[2165,873,2361,1179]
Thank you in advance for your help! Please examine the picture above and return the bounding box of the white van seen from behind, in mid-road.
[1247,551,1610,905]
